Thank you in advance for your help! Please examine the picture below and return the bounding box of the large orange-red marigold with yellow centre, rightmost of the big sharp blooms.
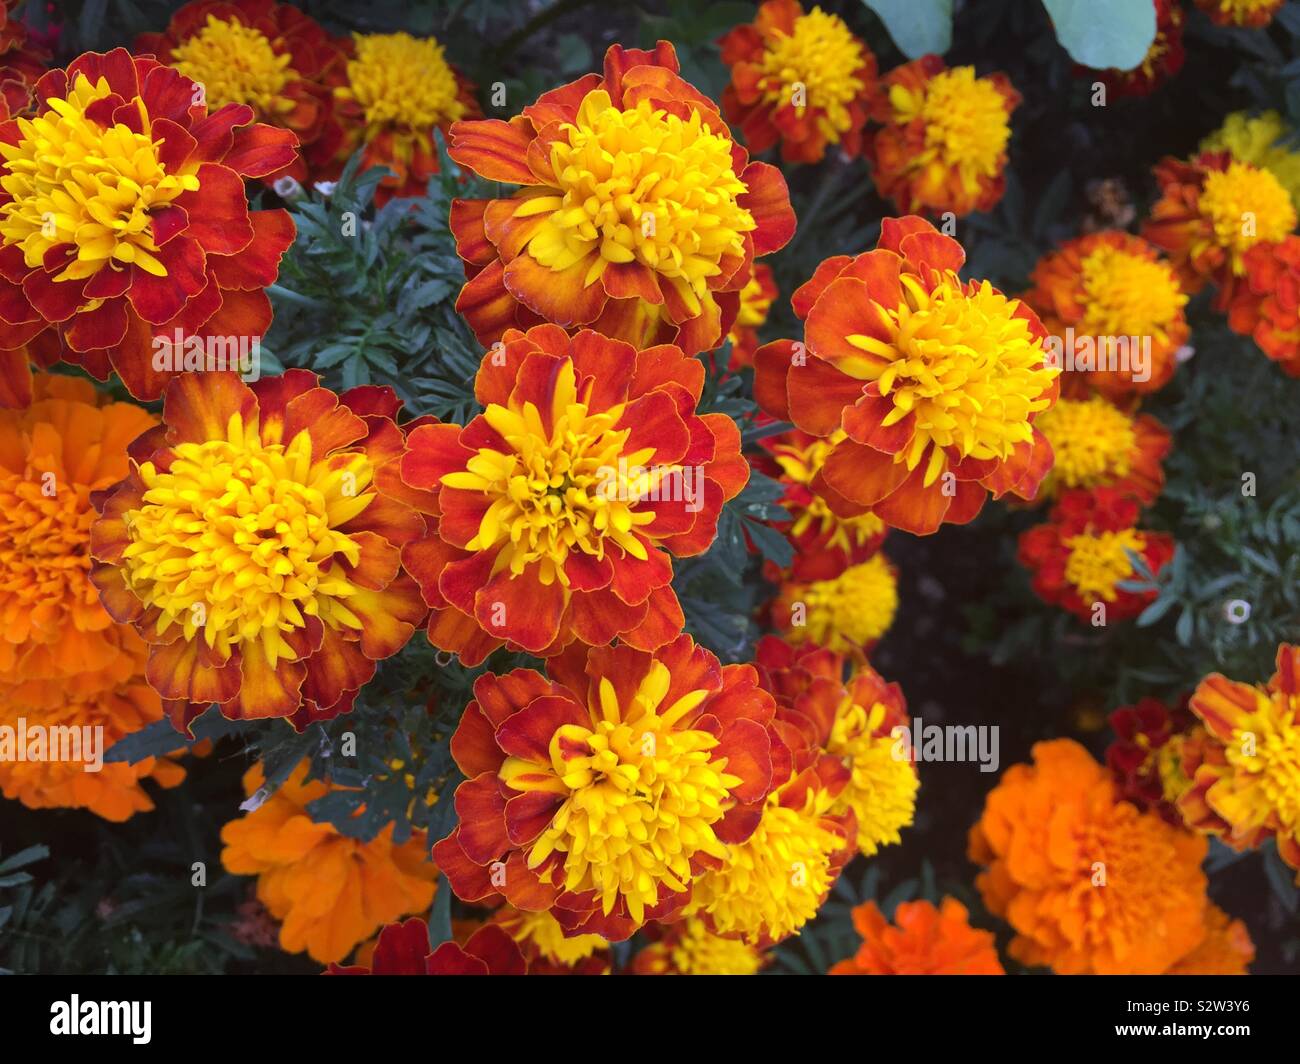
[754,216,1060,535]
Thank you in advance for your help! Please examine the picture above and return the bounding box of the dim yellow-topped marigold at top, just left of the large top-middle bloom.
[334,33,481,206]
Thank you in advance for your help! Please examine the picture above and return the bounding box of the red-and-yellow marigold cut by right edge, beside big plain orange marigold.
[1178,644,1300,882]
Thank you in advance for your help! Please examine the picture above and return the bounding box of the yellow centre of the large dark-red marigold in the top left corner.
[0,74,199,283]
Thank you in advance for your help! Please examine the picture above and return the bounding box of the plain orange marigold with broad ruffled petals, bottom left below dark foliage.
[221,761,438,964]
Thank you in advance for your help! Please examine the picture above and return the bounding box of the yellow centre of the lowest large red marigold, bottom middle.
[501,661,741,922]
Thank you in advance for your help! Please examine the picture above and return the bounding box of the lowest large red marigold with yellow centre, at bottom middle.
[433,635,790,942]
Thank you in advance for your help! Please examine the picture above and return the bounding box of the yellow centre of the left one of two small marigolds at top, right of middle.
[758,8,866,144]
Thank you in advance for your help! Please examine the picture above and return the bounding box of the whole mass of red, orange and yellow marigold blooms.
[0,0,1300,974]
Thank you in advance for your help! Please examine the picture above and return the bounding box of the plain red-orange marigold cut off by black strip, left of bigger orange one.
[829,898,1006,976]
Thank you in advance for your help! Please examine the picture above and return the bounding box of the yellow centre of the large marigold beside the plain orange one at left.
[122,414,374,665]
